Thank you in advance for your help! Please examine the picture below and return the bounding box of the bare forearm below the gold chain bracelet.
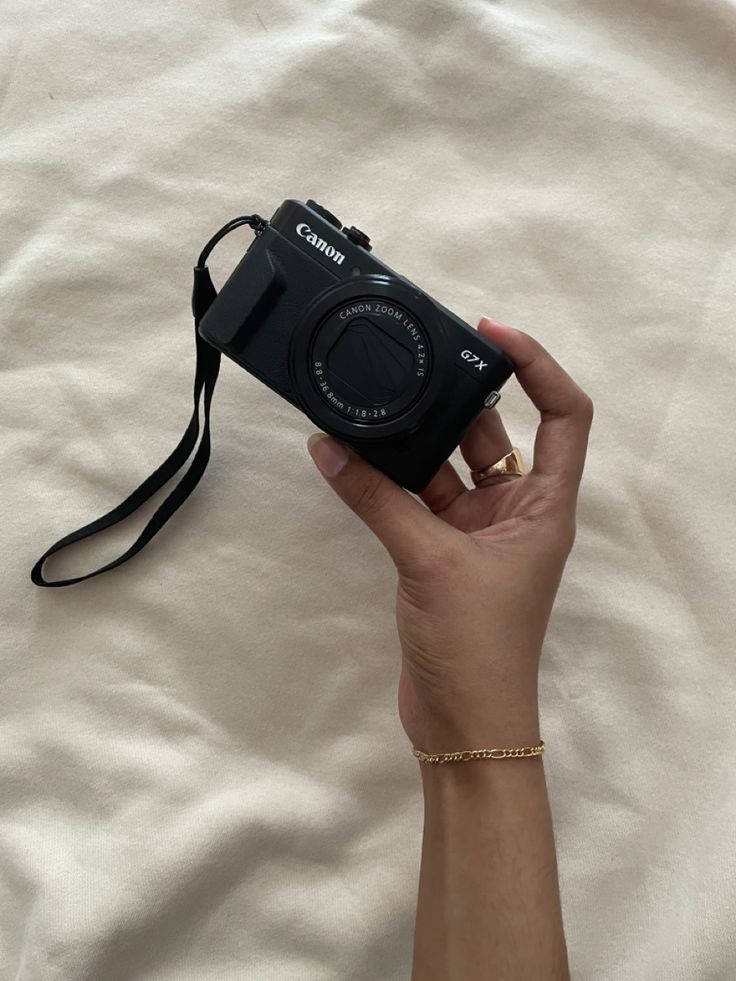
[412,747,569,981]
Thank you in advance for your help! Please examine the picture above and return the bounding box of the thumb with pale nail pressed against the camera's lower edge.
[307,433,447,566]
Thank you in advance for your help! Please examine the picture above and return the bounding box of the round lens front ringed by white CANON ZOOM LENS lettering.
[310,296,430,424]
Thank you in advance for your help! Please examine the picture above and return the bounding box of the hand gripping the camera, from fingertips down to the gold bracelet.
[309,318,593,752]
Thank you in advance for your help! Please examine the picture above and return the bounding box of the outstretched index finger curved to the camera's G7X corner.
[478,317,593,492]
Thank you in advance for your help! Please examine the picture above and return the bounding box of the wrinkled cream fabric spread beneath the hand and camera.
[0,0,736,981]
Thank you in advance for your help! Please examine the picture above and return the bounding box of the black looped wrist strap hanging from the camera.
[31,215,268,586]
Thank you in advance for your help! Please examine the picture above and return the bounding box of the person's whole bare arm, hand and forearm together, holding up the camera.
[310,318,593,981]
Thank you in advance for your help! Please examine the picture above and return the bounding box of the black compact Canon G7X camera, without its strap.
[199,199,514,492]
